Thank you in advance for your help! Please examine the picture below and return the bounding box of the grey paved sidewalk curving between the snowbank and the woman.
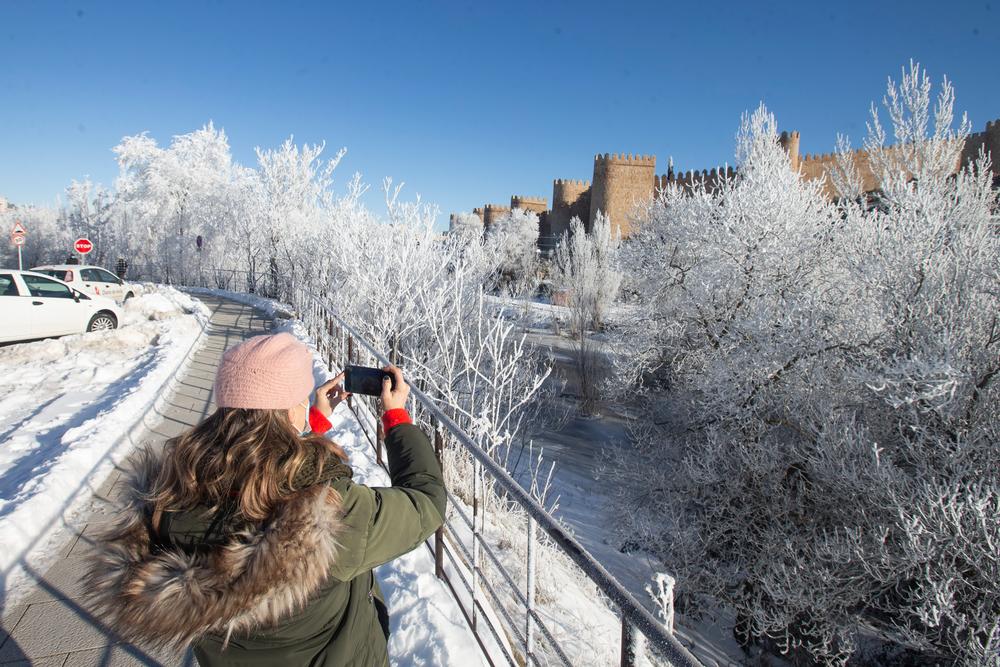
[0,294,273,667]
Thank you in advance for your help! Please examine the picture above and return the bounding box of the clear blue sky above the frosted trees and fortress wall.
[0,0,1000,227]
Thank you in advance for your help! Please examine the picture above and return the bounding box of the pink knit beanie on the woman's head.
[215,332,313,410]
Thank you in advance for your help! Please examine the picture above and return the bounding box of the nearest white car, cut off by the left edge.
[0,269,122,343]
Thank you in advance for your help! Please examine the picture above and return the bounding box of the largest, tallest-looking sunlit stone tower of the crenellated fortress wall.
[587,153,656,238]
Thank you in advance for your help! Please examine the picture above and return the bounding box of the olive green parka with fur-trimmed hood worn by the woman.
[87,424,446,667]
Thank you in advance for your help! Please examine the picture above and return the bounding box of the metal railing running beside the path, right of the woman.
[292,291,700,667]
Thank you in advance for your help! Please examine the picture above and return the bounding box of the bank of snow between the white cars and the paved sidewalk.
[0,288,209,606]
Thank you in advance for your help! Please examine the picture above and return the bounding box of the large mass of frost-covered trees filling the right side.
[619,66,1000,665]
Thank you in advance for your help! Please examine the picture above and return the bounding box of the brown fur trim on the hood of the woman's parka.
[84,450,343,647]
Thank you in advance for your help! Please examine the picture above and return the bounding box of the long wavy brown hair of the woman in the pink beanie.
[148,408,347,523]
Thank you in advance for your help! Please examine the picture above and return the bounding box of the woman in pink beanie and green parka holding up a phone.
[86,333,445,667]
